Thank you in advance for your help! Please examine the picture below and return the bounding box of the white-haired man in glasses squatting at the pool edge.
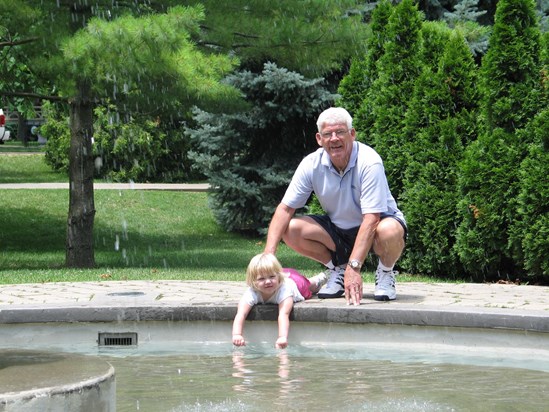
[265,107,406,305]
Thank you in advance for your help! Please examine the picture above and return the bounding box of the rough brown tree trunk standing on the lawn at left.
[66,83,95,268]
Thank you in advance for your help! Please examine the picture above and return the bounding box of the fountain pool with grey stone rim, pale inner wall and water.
[0,282,549,412]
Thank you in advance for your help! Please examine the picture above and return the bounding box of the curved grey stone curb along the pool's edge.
[0,303,549,333]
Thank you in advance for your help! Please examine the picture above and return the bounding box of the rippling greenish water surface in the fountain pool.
[101,345,549,412]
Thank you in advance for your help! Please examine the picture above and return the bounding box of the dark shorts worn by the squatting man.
[308,215,408,266]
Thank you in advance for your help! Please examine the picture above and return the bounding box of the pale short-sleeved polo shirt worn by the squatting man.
[282,141,405,229]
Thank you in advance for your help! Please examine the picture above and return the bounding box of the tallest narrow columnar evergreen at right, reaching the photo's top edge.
[457,0,546,279]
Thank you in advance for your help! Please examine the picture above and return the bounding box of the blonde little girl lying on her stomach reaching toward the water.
[233,253,327,349]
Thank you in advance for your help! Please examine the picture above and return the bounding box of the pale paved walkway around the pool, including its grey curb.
[0,280,549,333]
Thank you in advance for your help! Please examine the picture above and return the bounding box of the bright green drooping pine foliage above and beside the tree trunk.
[61,6,236,116]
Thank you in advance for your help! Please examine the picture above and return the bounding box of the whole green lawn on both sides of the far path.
[0,153,430,284]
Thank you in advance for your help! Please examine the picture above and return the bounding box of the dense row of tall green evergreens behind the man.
[340,0,549,281]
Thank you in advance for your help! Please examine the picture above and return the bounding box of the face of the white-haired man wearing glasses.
[316,123,356,169]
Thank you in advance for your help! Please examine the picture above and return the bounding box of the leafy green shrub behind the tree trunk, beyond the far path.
[40,105,197,182]
